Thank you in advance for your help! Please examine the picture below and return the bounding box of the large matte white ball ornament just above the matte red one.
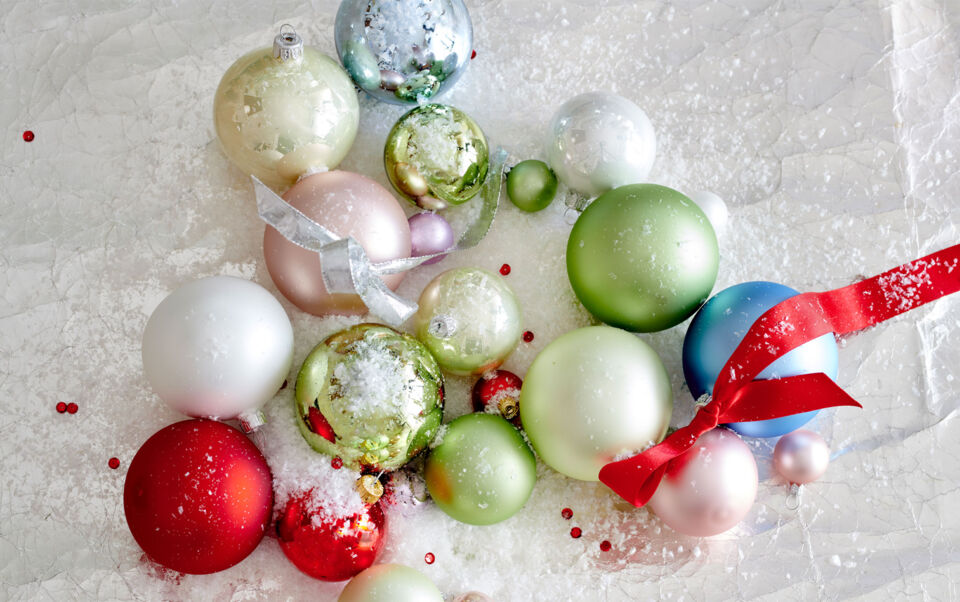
[142,276,293,431]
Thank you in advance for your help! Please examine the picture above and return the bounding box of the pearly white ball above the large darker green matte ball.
[547,92,657,197]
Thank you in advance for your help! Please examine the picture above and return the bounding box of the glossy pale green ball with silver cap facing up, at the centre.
[414,268,522,375]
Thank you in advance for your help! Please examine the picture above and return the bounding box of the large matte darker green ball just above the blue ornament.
[567,184,720,332]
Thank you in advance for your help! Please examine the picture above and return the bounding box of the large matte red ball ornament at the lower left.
[123,420,273,575]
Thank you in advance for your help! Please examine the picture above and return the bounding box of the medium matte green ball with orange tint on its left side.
[424,414,537,525]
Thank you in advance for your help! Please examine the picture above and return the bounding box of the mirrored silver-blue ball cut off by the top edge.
[334,0,473,104]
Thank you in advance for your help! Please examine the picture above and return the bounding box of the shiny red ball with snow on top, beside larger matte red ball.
[277,489,387,581]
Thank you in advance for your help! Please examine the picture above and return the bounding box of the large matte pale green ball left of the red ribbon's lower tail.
[520,326,673,481]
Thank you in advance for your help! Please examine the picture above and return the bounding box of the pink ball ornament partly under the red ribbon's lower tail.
[650,428,757,537]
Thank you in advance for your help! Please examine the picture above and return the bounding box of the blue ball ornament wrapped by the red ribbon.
[683,282,839,437]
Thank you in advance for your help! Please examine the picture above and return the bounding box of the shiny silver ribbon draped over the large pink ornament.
[250,148,507,326]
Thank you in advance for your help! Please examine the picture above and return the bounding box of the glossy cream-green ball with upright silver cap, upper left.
[213,25,360,188]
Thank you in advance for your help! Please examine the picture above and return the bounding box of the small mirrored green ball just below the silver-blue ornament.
[383,105,490,210]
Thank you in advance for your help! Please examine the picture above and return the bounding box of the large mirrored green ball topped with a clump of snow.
[294,324,443,470]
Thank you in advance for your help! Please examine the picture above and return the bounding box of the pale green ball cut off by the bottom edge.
[337,564,443,602]
